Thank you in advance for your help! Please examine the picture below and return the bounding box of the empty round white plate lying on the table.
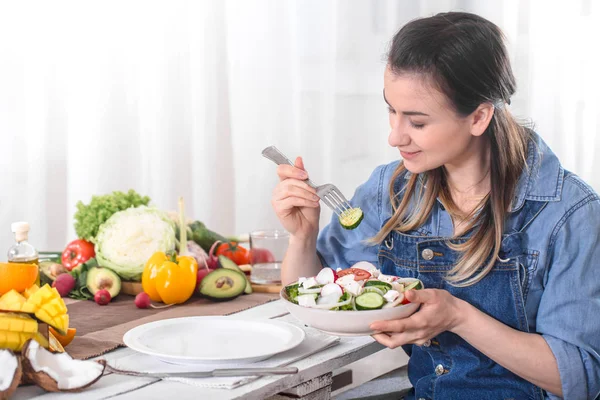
[123,317,305,365]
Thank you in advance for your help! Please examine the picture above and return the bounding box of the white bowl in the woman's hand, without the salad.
[279,287,419,336]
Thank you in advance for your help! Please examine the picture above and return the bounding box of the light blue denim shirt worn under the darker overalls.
[317,135,600,399]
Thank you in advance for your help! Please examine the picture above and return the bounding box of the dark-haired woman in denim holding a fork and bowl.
[272,13,600,399]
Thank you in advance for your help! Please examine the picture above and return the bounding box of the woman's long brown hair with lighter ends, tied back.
[373,12,530,286]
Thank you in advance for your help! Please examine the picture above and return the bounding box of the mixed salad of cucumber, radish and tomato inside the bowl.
[285,261,423,311]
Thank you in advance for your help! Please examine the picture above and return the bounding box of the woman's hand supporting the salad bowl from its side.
[371,289,467,349]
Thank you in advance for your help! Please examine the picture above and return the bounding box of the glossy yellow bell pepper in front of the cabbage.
[142,251,198,304]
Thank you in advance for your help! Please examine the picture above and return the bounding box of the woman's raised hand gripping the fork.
[271,157,320,238]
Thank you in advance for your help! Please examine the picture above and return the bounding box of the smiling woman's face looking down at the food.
[384,68,488,173]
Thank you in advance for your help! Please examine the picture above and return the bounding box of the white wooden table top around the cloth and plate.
[11,300,384,400]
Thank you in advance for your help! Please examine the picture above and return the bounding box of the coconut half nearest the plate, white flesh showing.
[22,340,104,392]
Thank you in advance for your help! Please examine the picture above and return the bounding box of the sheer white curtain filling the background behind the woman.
[0,0,600,252]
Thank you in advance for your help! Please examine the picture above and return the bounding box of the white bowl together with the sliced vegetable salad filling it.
[280,262,423,336]
